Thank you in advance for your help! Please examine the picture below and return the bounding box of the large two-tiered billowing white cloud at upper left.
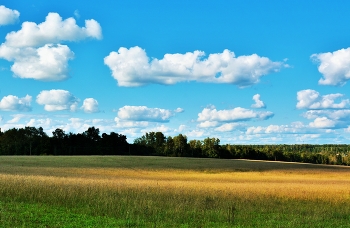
[0,13,102,81]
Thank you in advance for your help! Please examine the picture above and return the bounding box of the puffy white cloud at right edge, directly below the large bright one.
[296,89,350,109]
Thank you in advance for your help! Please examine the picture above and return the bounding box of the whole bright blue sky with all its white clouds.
[0,0,350,144]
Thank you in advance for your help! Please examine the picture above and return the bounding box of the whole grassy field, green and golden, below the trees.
[0,156,350,227]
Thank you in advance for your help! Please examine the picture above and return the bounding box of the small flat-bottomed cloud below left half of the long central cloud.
[118,106,174,122]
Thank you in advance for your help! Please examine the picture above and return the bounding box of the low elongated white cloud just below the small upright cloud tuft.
[197,107,274,122]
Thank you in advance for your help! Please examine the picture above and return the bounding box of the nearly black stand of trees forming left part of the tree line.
[0,127,129,155]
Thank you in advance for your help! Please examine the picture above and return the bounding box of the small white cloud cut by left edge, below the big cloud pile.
[0,95,32,112]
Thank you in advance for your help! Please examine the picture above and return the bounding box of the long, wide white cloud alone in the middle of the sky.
[104,46,287,87]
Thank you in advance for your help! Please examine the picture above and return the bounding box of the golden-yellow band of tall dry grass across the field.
[0,168,350,201]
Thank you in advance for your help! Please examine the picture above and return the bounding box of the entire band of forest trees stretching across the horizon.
[0,127,350,166]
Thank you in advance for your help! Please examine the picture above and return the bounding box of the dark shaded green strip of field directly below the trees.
[0,156,350,173]
